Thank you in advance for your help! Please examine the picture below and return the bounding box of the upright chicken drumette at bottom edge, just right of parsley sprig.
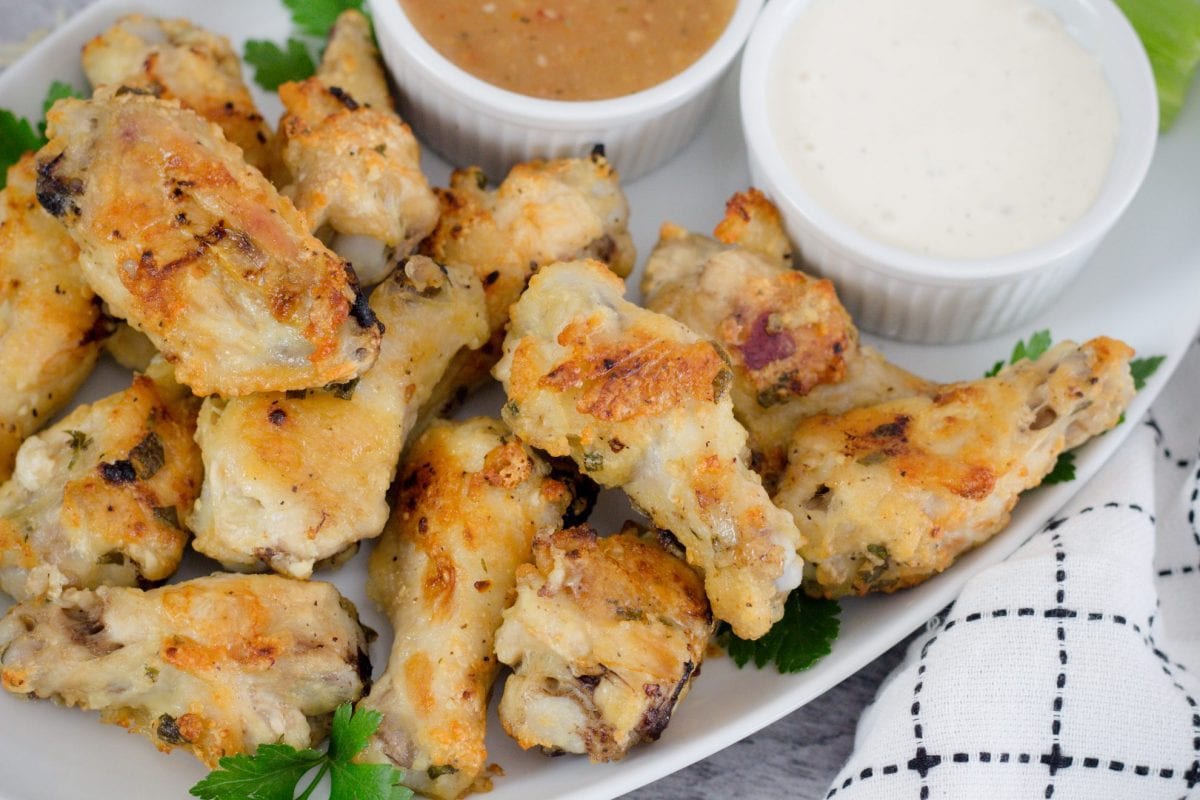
[362,417,571,798]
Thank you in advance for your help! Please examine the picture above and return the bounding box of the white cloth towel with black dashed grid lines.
[826,335,1200,800]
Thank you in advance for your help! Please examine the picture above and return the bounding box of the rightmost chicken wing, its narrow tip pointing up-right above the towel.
[775,338,1134,597]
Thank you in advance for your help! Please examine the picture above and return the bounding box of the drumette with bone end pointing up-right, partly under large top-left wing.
[188,255,487,578]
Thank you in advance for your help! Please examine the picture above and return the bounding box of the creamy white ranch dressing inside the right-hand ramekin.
[768,0,1118,258]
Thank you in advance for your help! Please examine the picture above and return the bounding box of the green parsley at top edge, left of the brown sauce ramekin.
[242,0,365,91]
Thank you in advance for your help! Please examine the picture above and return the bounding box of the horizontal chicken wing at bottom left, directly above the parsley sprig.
[0,575,371,768]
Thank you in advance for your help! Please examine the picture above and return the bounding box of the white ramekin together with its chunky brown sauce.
[370,0,763,180]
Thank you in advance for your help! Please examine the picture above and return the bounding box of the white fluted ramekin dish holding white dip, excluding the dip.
[740,0,1158,343]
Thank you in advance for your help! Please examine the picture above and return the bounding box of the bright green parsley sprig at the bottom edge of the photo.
[191,703,413,800]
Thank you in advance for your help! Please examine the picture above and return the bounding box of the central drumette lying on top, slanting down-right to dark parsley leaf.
[496,261,802,638]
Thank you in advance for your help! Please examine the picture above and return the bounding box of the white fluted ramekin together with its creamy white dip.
[742,0,1158,343]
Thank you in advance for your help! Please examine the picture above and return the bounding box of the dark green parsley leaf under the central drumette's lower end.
[716,589,841,673]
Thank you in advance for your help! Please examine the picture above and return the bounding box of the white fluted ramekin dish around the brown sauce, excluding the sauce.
[371,0,763,180]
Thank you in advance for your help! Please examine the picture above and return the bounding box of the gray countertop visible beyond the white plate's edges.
[0,0,904,800]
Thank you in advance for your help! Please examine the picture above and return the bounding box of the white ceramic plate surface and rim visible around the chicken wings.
[0,0,1200,800]
